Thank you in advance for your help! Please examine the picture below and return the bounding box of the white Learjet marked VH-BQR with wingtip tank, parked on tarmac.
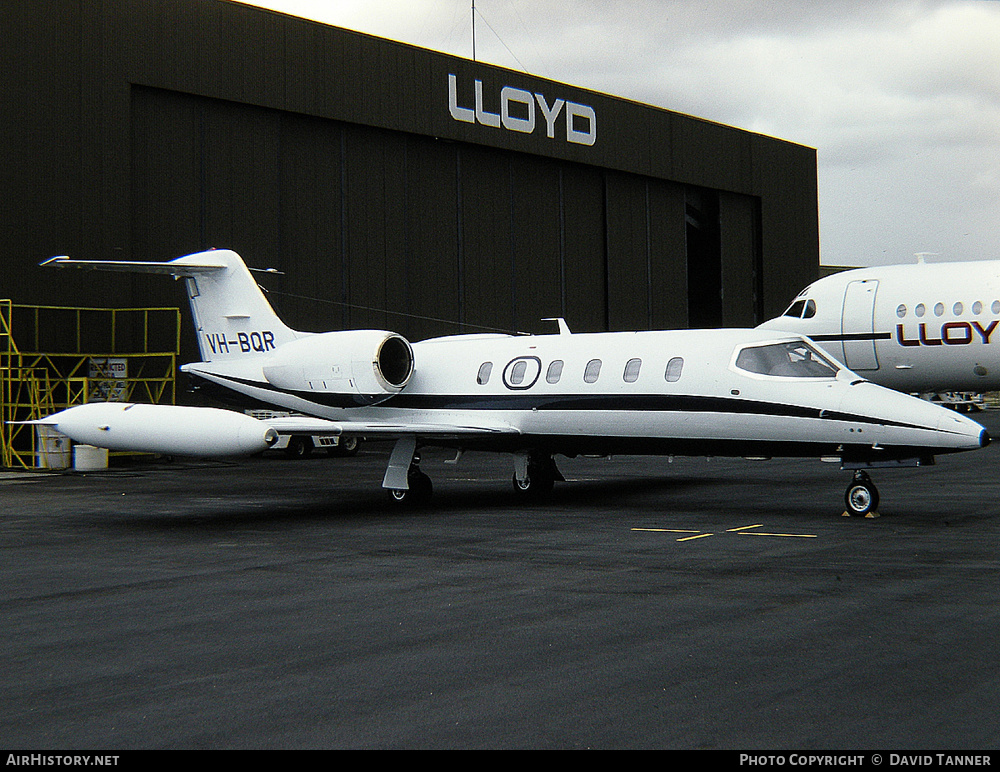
[33,250,989,515]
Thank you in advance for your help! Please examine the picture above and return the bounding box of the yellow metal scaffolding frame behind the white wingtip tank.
[0,300,181,468]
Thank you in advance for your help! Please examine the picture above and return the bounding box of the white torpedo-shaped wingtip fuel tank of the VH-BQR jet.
[36,402,278,458]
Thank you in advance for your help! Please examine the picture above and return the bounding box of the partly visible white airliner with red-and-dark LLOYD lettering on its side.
[759,259,1000,394]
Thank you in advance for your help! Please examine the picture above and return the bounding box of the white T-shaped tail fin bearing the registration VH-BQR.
[43,249,305,362]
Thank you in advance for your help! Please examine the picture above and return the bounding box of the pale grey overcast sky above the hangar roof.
[236,0,1000,265]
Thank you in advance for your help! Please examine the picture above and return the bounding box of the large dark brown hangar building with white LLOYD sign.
[0,0,819,358]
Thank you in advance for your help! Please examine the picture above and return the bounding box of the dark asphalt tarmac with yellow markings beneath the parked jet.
[0,413,1000,751]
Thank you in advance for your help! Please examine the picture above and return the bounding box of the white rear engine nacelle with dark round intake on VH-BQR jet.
[263,330,413,405]
